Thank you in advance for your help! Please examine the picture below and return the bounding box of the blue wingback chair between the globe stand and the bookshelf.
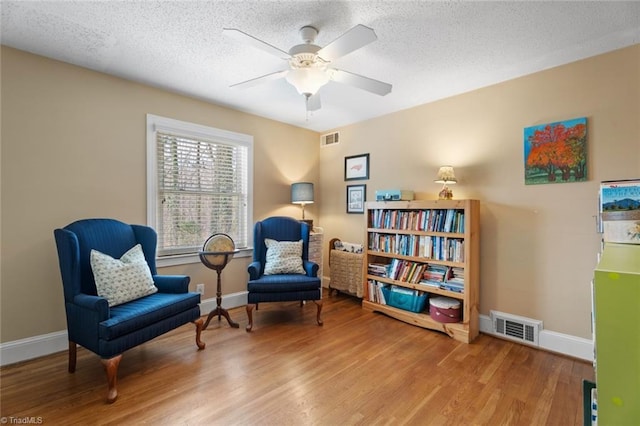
[246,216,322,331]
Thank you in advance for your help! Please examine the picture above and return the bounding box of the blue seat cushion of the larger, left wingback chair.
[98,293,200,340]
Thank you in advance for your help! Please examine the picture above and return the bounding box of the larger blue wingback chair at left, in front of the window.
[54,219,205,403]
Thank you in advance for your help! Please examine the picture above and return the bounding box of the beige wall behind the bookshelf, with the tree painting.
[319,45,640,339]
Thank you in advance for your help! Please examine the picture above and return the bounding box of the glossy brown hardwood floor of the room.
[0,292,593,426]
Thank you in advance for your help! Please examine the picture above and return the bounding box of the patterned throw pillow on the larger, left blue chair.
[91,244,158,306]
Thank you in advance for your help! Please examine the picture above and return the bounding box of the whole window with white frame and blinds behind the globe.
[147,114,253,266]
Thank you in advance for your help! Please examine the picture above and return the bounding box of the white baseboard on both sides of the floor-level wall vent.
[480,315,593,362]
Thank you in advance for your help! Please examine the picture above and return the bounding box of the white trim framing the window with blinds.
[147,114,254,267]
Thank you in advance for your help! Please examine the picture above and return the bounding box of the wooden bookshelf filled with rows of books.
[362,200,480,343]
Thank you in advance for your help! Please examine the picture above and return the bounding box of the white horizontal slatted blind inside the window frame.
[156,131,249,256]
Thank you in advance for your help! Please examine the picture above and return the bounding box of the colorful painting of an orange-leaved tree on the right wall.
[524,118,587,185]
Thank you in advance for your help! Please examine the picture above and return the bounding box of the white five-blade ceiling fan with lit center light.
[223,25,392,111]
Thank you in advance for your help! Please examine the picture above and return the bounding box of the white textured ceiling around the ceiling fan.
[0,0,640,132]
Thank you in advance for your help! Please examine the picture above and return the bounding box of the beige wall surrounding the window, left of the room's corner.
[0,46,319,342]
